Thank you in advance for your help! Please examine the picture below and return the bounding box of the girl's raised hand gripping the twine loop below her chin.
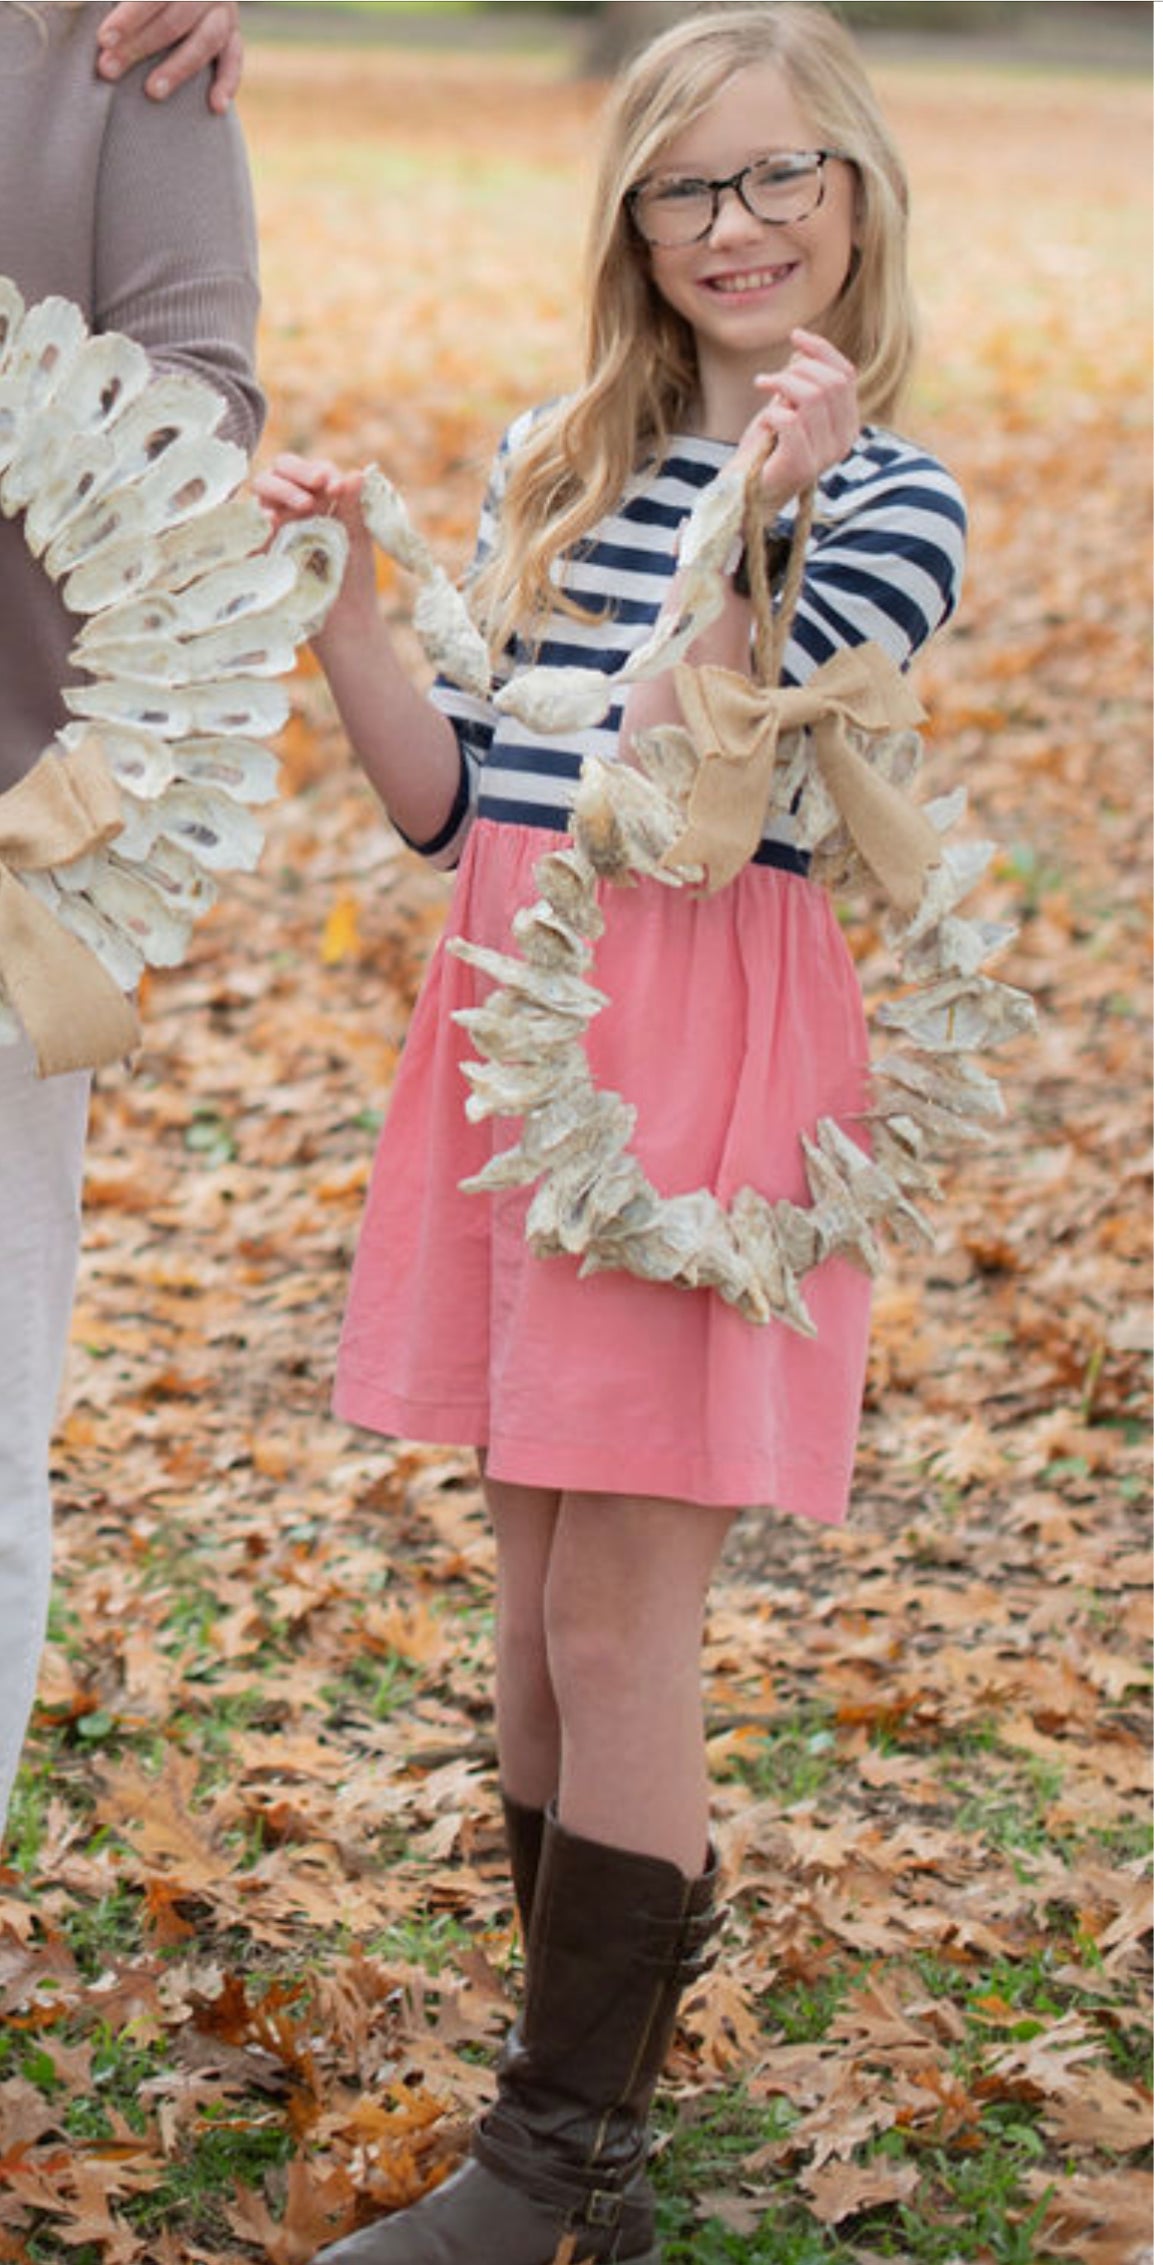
[739,331,861,510]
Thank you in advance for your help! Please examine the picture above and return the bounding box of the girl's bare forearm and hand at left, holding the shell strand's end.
[254,455,465,849]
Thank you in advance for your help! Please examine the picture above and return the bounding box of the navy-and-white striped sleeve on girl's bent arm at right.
[784,433,966,684]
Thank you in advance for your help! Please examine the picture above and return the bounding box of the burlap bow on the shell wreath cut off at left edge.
[0,736,141,1078]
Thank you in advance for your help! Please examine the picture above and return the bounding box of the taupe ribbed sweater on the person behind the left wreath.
[0,0,263,790]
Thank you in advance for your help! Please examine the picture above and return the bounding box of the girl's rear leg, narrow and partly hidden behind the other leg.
[485,1479,562,1810]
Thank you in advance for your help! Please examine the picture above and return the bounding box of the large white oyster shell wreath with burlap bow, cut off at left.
[0,276,347,1074]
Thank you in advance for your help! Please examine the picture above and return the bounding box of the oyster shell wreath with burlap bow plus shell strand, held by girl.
[363,467,1034,1336]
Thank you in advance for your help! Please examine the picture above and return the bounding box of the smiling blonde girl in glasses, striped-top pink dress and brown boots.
[261,5,963,2265]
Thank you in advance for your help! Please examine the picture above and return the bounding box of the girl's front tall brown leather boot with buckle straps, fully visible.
[315,1814,716,2265]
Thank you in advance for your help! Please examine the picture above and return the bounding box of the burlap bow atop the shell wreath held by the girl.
[662,643,941,915]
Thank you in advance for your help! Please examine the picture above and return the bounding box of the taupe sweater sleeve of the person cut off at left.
[93,63,265,453]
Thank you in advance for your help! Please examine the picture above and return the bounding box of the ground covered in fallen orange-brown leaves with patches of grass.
[0,31,1152,2265]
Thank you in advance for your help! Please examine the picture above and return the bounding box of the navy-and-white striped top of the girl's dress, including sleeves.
[415,417,966,872]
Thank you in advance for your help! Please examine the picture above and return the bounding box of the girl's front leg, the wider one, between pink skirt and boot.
[544,1495,735,1878]
